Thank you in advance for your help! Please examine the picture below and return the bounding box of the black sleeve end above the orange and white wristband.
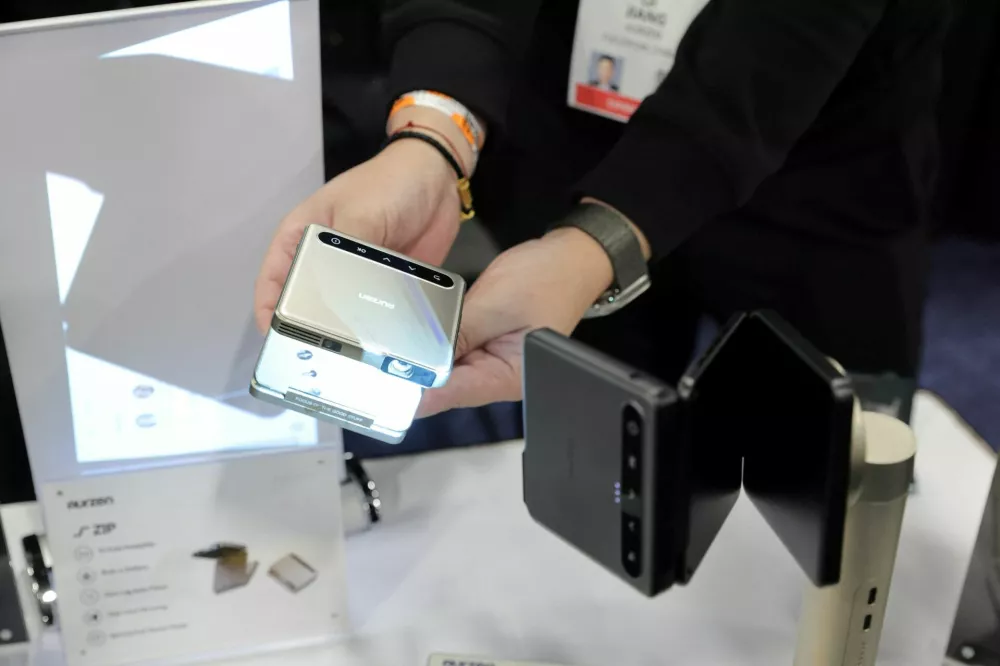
[383,0,541,130]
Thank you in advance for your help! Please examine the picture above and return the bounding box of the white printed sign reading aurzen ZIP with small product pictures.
[42,450,347,666]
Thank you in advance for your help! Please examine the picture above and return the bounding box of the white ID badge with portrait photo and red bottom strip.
[567,0,708,122]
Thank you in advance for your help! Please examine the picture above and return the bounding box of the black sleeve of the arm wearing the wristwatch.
[578,0,890,256]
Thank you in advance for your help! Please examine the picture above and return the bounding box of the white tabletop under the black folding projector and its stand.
[5,395,996,666]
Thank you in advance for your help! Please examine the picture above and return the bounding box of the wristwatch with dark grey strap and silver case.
[555,204,650,319]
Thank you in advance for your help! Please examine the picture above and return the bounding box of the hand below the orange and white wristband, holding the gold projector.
[254,139,460,332]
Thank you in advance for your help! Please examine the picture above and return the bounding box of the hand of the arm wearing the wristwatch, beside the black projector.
[418,228,614,416]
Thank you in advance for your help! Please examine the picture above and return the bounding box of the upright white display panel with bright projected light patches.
[0,0,339,483]
